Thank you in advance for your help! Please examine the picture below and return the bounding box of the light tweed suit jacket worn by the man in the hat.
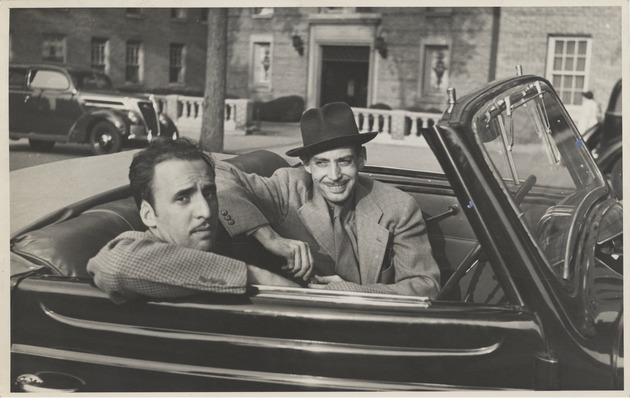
[216,162,439,297]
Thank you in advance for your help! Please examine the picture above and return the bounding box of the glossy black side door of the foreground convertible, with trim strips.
[11,270,544,392]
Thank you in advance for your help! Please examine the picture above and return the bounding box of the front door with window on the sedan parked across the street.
[26,68,83,136]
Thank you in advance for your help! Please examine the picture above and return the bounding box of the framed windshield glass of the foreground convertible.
[473,82,604,279]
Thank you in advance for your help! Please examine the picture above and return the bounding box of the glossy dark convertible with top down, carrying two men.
[5,71,624,393]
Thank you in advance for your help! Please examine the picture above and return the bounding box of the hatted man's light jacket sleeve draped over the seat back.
[215,161,295,236]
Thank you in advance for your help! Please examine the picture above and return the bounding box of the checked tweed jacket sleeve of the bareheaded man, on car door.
[87,231,247,304]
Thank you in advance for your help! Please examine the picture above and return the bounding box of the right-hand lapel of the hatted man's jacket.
[355,184,389,284]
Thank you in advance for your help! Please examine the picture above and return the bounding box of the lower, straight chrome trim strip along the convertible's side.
[11,344,512,391]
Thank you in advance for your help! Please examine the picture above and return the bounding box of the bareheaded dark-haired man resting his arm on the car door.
[87,139,298,303]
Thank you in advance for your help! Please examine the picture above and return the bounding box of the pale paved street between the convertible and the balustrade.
[9,122,440,171]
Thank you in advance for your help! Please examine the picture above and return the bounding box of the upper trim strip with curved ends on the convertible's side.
[41,304,501,358]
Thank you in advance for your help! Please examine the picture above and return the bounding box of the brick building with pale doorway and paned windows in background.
[10,6,625,116]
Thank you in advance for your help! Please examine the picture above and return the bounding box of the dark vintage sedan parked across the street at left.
[9,64,179,155]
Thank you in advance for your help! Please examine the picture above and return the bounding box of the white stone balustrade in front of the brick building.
[154,95,442,146]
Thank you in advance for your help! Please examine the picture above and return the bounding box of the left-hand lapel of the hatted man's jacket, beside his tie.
[298,187,335,261]
